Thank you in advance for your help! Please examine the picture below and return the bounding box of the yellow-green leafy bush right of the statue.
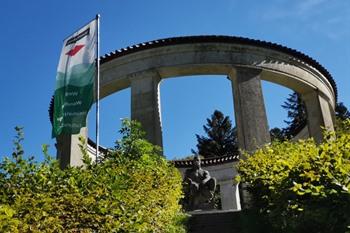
[238,120,350,232]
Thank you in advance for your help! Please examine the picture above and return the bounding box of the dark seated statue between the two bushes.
[183,156,216,210]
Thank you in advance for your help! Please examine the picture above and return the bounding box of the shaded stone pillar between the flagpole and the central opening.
[130,71,163,147]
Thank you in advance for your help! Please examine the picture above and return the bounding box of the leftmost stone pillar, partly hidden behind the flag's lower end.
[56,127,87,169]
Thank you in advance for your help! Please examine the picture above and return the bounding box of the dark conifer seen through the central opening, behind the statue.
[192,110,238,158]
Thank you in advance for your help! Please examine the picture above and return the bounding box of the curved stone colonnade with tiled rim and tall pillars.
[57,36,337,167]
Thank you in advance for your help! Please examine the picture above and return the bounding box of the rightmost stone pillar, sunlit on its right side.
[301,90,335,142]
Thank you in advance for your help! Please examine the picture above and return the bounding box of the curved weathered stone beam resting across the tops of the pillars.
[101,39,335,108]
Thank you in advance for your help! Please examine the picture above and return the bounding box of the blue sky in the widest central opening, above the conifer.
[160,75,235,159]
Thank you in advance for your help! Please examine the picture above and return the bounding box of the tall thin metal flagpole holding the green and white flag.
[96,14,100,163]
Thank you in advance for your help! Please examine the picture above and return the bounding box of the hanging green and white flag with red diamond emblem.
[53,20,97,137]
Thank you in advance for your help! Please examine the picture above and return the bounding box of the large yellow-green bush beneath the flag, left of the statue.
[0,121,185,232]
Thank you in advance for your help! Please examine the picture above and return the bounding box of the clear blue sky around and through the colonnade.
[0,0,350,160]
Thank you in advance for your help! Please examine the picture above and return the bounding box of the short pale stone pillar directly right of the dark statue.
[220,180,241,210]
